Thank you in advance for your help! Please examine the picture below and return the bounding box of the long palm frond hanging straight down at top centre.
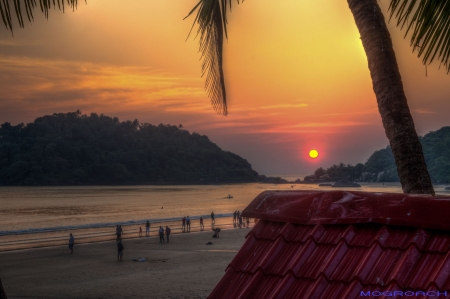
[185,0,243,115]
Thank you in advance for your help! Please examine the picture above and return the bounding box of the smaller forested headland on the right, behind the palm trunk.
[305,127,450,184]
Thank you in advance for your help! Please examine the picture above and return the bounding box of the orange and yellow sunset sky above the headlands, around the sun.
[0,0,450,174]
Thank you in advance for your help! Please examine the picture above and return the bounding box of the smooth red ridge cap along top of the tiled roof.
[242,190,450,230]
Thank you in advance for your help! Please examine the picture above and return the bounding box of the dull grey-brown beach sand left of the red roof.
[0,228,250,299]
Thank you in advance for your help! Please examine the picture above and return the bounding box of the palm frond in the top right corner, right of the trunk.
[389,0,450,73]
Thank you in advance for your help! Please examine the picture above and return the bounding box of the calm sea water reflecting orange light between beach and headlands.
[0,183,449,251]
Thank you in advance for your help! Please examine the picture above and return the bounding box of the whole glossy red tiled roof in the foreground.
[209,191,450,299]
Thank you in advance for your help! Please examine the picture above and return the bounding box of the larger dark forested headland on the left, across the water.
[0,111,258,185]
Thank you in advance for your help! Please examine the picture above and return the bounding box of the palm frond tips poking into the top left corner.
[0,0,83,32]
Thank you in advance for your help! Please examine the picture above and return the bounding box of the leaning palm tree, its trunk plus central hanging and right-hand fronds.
[184,0,450,195]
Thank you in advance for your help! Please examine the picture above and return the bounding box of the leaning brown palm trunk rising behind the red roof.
[347,0,434,195]
